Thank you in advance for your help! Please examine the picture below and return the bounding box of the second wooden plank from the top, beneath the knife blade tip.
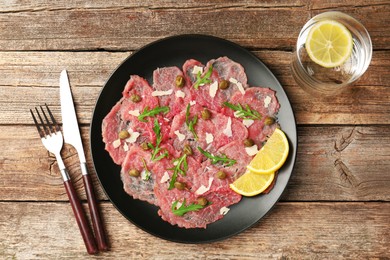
[0,51,390,124]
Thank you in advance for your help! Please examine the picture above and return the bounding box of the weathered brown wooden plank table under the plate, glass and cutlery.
[0,0,390,259]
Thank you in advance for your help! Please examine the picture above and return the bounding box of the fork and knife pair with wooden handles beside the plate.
[30,70,109,254]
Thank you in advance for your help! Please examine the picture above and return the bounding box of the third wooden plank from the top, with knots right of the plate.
[0,126,390,201]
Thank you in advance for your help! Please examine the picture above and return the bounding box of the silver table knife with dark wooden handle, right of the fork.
[60,70,109,251]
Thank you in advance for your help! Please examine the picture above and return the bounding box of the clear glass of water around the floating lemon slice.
[291,11,372,96]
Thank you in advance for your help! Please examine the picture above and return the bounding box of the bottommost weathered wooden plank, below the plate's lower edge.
[0,202,390,259]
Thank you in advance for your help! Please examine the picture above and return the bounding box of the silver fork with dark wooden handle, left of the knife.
[30,104,98,254]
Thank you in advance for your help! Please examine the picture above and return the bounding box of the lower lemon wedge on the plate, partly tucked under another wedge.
[230,170,275,197]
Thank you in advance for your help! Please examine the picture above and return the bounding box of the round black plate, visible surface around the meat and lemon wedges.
[90,35,297,243]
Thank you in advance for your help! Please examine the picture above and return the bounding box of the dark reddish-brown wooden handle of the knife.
[83,174,109,251]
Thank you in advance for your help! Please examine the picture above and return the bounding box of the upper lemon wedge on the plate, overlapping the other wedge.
[247,128,289,174]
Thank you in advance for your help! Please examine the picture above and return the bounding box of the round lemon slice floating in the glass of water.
[305,20,353,68]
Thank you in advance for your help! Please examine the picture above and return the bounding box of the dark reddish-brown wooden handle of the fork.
[64,180,98,255]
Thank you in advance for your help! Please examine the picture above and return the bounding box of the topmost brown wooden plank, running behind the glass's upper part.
[0,0,390,50]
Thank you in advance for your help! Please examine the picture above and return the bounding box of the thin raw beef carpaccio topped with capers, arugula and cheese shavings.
[102,57,280,228]
